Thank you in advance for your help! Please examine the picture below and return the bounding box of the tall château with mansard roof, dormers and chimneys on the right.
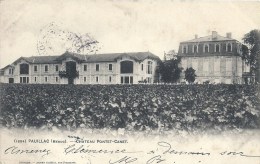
[178,31,247,84]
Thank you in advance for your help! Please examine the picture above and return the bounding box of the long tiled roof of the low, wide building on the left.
[2,52,160,66]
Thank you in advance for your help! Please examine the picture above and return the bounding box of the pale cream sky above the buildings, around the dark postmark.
[0,0,260,68]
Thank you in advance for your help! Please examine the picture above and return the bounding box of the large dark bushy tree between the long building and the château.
[159,58,182,83]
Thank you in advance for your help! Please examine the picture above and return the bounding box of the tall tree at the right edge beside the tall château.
[242,29,260,82]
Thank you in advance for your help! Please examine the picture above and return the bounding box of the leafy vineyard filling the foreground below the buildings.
[0,84,260,132]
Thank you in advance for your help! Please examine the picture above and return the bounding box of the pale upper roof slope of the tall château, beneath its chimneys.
[181,34,235,43]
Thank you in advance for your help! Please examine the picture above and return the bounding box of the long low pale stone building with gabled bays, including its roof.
[0,52,160,84]
